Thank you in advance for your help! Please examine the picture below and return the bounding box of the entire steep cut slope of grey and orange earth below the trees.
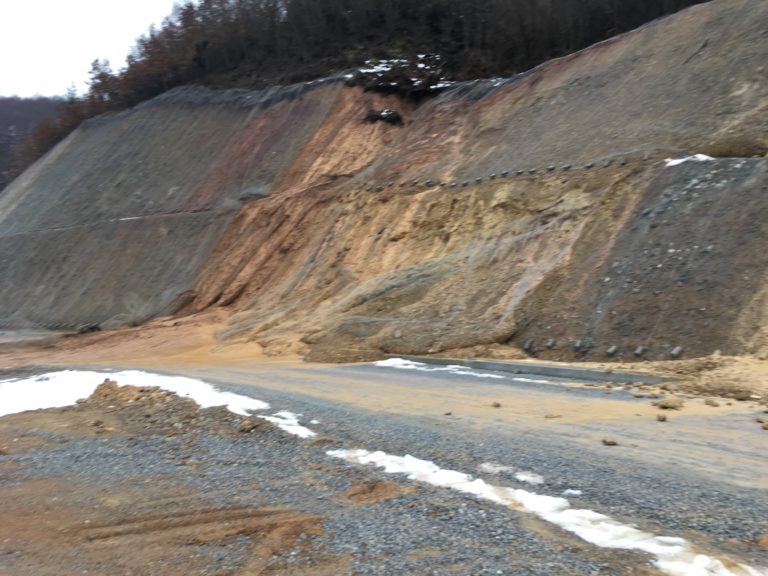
[0,0,768,361]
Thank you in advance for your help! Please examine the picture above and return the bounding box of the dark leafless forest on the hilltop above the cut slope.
[9,0,702,179]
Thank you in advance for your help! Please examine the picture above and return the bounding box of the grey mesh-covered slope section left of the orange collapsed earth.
[0,81,390,328]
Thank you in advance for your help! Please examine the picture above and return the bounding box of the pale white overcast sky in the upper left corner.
[0,0,174,96]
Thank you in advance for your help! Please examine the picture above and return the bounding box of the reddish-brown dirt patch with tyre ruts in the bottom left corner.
[0,478,332,576]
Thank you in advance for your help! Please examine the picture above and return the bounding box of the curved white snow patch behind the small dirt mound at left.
[0,370,269,416]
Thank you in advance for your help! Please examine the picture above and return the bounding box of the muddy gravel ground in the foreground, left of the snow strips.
[0,381,655,576]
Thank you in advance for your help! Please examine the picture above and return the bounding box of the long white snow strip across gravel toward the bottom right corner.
[327,450,768,576]
